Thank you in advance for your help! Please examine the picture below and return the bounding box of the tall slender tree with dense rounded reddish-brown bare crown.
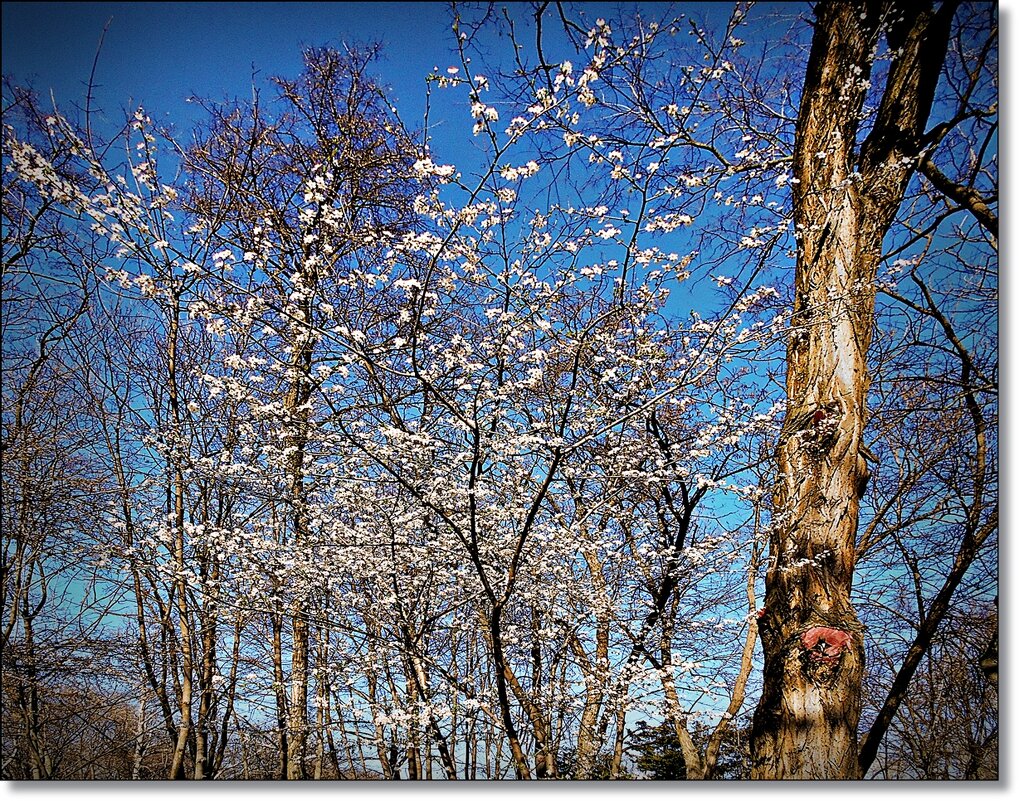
[184,42,421,779]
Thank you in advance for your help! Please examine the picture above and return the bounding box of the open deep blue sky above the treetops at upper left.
[2,2,452,129]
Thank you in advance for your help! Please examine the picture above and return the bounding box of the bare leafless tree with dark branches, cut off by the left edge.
[0,85,127,779]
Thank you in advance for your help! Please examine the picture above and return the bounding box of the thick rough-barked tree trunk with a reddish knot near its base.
[752,0,958,780]
